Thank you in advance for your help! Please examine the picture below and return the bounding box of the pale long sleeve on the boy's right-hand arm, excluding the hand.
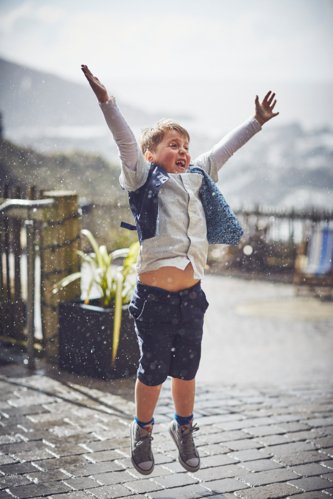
[193,118,261,182]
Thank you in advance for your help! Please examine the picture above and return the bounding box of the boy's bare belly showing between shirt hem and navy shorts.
[139,263,199,291]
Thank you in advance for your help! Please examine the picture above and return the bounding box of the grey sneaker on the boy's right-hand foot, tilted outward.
[169,420,200,471]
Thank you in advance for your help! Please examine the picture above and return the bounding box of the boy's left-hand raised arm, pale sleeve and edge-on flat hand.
[81,64,148,190]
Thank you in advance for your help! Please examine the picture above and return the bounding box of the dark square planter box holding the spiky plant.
[59,302,140,379]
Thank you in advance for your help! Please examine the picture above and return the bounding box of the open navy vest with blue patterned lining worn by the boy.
[121,163,243,245]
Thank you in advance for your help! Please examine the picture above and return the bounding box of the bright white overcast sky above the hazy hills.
[0,0,333,131]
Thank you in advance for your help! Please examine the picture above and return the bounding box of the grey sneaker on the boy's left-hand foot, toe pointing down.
[131,421,155,475]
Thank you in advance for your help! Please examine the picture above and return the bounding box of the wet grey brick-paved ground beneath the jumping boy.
[0,276,333,499]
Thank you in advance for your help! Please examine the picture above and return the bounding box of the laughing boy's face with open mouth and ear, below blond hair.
[145,130,191,173]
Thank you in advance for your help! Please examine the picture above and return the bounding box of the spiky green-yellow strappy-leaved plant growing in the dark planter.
[53,229,139,363]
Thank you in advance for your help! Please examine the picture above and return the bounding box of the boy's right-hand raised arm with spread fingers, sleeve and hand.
[194,92,279,182]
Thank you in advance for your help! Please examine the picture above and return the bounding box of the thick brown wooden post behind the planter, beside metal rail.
[40,191,81,361]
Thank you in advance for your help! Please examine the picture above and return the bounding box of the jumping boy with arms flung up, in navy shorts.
[81,65,278,475]
